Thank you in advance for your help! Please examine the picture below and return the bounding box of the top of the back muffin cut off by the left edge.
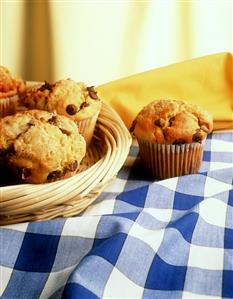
[0,66,25,99]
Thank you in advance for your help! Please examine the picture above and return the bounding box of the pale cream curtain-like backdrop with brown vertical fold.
[0,0,233,85]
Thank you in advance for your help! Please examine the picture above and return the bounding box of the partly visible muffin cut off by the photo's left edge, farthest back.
[0,66,25,117]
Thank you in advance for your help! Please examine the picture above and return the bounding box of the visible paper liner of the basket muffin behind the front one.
[77,112,99,146]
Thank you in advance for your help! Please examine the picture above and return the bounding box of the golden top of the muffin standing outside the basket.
[130,99,213,144]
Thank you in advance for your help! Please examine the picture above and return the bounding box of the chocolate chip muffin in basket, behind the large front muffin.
[20,79,101,145]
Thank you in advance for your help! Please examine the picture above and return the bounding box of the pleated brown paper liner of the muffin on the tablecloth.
[138,140,204,179]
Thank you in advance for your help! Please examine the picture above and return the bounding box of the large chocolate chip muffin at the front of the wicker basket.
[0,110,86,183]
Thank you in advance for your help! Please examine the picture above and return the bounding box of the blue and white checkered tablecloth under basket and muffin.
[0,132,233,299]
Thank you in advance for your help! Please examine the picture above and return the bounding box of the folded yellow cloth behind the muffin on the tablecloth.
[97,53,233,130]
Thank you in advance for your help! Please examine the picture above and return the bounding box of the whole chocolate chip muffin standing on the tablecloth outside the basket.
[130,99,213,179]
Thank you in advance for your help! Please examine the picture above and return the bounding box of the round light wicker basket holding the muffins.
[0,104,132,225]
